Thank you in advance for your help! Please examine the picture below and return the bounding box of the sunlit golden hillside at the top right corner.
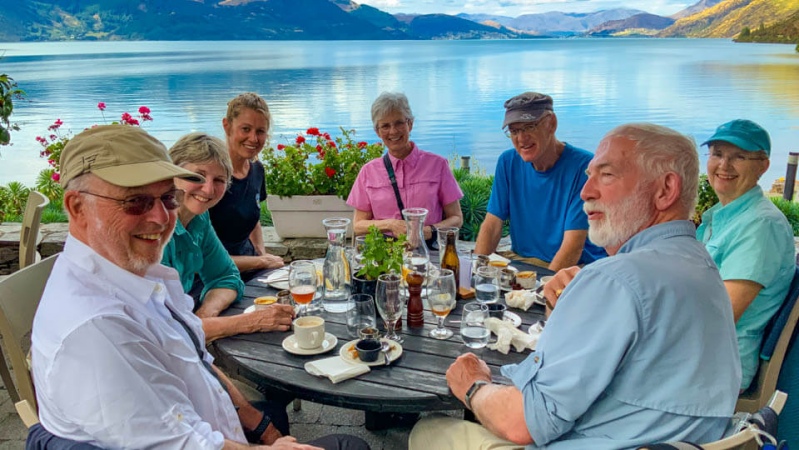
[658,0,799,38]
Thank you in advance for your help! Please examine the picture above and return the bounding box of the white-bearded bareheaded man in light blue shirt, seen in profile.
[410,124,741,450]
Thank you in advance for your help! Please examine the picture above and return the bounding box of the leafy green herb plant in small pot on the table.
[352,225,406,297]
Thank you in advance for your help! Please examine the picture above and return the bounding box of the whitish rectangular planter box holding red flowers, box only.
[266,195,353,239]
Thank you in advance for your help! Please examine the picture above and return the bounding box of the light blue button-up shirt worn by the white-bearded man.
[502,221,741,450]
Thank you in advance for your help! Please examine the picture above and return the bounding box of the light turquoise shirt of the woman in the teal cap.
[696,186,796,389]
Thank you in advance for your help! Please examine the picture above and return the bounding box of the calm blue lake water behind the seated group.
[0,39,799,187]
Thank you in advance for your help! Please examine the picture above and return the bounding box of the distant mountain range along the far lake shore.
[0,0,799,42]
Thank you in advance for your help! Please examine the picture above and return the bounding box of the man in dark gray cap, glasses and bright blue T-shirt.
[474,92,606,270]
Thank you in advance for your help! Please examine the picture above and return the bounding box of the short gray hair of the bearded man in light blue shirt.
[604,123,699,218]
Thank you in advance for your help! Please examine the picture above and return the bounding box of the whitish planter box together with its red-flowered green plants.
[261,127,383,238]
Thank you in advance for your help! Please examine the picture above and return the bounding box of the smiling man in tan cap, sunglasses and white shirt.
[29,125,368,449]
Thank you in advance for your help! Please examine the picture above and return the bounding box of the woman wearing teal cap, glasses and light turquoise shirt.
[696,119,795,390]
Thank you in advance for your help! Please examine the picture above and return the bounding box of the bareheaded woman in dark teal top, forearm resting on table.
[161,133,294,342]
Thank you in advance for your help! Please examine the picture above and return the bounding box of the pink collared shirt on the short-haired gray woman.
[347,142,463,225]
